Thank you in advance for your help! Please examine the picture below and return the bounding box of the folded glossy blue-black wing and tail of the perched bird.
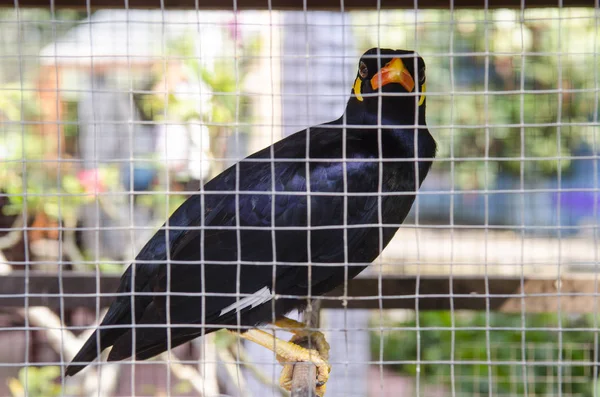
[68,129,414,368]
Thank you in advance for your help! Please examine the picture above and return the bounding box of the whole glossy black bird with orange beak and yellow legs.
[66,48,436,395]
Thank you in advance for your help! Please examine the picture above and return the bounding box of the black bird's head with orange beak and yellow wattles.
[351,48,426,124]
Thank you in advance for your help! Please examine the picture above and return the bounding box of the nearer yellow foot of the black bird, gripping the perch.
[277,338,331,397]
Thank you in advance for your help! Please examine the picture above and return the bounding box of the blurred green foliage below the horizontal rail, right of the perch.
[371,311,596,396]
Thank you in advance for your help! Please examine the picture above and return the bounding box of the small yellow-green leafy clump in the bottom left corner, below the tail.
[7,366,62,397]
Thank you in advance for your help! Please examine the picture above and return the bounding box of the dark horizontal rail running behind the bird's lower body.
[0,272,598,313]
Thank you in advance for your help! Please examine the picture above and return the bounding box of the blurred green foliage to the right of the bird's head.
[356,9,598,184]
